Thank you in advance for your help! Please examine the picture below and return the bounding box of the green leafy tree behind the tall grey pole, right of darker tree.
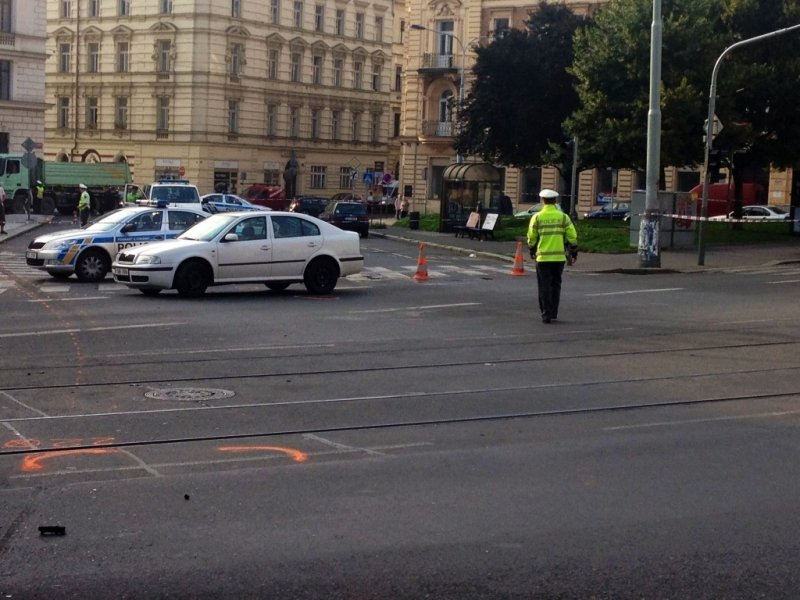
[566,0,720,170]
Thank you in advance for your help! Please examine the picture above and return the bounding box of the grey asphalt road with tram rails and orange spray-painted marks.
[0,227,800,599]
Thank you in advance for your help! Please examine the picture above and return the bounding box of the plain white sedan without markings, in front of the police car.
[111,211,364,297]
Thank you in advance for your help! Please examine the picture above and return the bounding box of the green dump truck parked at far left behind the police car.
[0,154,131,215]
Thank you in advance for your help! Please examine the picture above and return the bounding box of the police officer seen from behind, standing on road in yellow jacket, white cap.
[528,189,578,323]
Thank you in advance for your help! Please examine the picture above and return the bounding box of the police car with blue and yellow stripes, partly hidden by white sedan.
[25,205,209,282]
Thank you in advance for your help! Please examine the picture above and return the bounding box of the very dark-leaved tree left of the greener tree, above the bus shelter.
[456,1,583,167]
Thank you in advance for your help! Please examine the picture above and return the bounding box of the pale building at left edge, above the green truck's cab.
[0,0,47,153]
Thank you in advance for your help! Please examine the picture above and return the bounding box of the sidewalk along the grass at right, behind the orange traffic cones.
[370,219,800,274]
